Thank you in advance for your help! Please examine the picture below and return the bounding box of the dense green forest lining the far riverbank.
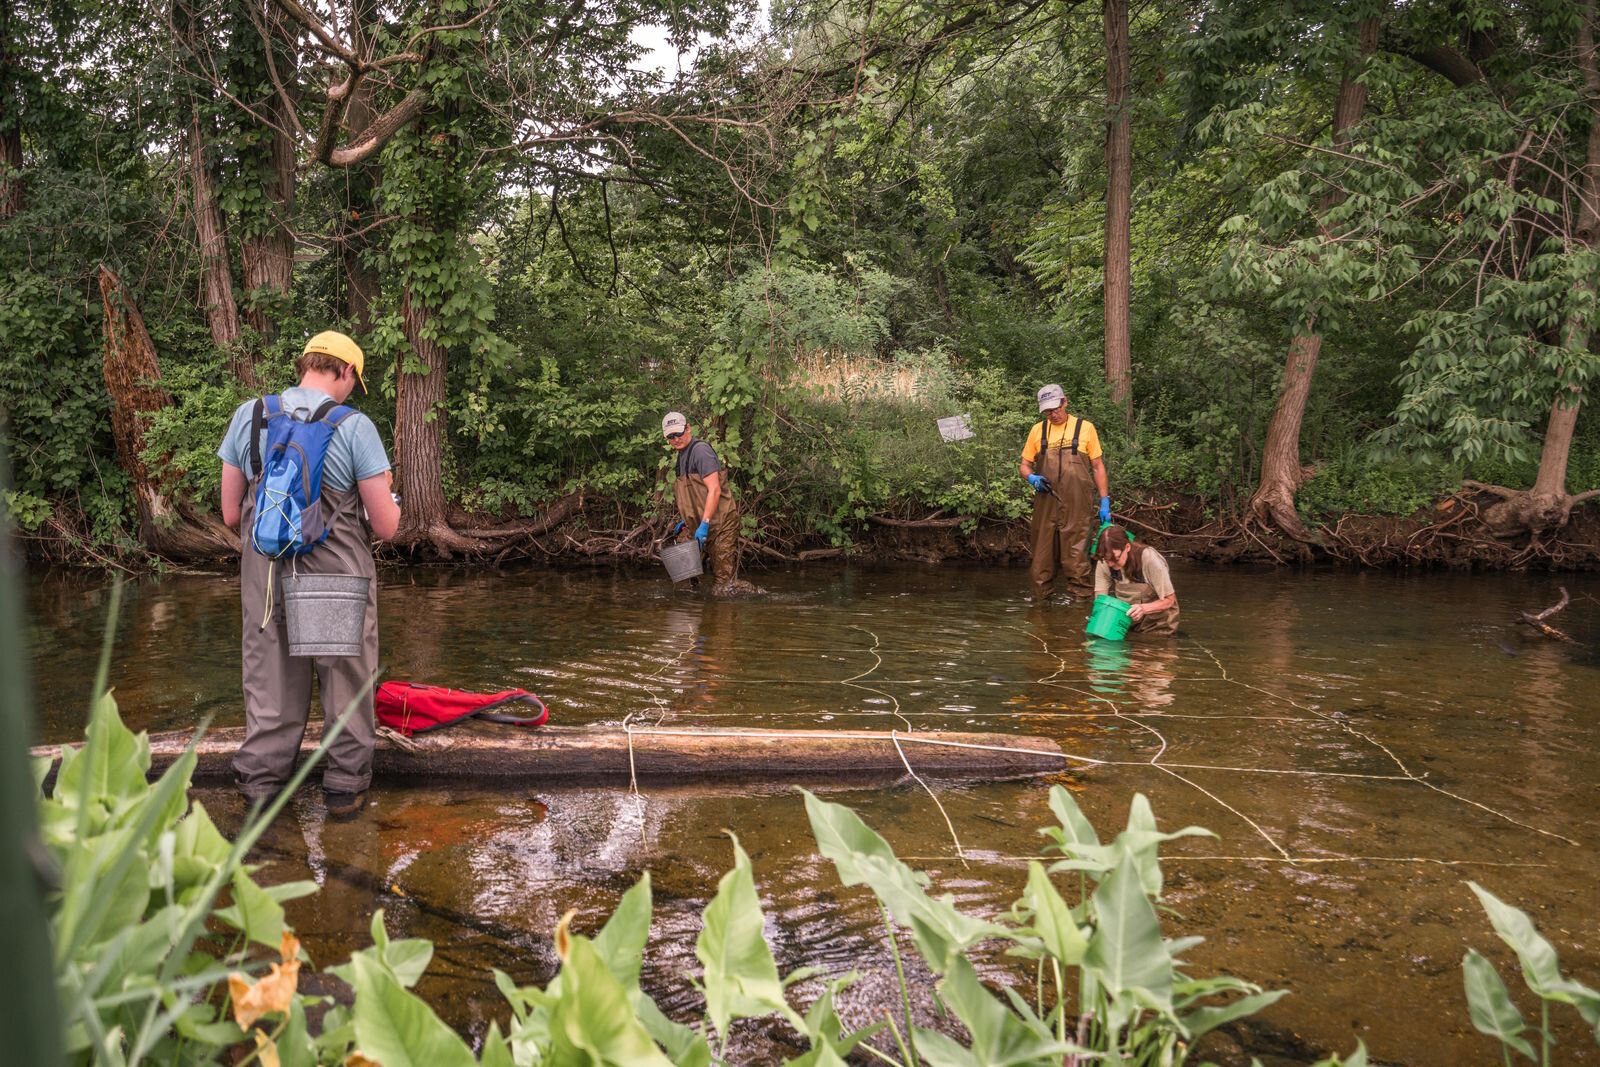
[0,0,1600,560]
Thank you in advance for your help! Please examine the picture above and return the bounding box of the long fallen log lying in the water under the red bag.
[34,721,1067,787]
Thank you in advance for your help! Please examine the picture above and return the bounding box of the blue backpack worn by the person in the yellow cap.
[250,395,355,560]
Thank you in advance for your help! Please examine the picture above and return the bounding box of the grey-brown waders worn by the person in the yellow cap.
[234,483,378,800]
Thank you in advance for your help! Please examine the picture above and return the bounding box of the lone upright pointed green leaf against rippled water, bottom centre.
[694,833,803,1040]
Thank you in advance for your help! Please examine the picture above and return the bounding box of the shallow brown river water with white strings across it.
[29,563,1600,1064]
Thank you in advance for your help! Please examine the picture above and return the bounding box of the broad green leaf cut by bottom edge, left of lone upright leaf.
[550,934,672,1067]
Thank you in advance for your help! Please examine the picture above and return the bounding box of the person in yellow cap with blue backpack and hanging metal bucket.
[216,331,400,819]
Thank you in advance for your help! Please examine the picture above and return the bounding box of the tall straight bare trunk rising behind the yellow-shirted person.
[1102,0,1133,427]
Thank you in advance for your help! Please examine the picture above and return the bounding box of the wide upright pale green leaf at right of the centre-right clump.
[1083,856,1173,1014]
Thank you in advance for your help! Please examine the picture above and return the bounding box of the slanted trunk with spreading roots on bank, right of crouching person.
[1250,18,1379,544]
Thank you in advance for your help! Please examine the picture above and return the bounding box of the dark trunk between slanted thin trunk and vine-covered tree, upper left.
[240,0,294,341]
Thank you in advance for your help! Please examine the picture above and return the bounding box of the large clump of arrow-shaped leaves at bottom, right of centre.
[802,785,1283,1065]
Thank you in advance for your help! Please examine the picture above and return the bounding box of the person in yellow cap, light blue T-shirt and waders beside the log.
[216,330,400,819]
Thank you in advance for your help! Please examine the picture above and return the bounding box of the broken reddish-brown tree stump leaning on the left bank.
[99,264,238,560]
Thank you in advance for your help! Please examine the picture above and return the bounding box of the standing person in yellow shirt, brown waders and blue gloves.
[1021,386,1110,601]
